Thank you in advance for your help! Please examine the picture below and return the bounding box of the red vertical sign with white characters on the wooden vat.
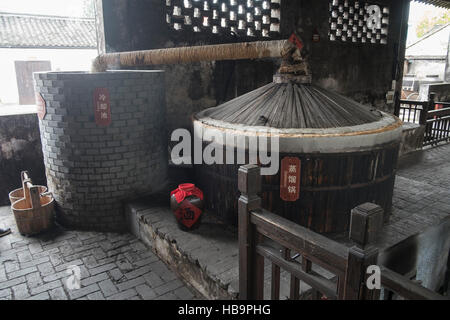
[280,157,301,201]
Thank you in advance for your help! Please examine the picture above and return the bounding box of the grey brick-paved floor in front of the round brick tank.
[0,207,198,300]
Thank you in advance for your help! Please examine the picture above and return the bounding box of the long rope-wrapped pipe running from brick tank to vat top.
[92,40,293,72]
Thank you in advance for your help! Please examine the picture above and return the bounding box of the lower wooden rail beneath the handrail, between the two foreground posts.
[256,244,337,299]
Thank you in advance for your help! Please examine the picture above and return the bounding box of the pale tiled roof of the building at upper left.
[0,13,97,48]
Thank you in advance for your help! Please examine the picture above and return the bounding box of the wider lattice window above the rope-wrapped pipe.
[166,0,281,38]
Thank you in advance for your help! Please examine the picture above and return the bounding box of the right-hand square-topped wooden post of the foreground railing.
[343,203,383,300]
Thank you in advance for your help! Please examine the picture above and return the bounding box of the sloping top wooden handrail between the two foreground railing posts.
[250,209,348,273]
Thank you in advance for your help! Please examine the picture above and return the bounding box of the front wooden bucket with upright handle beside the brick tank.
[11,180,55,236]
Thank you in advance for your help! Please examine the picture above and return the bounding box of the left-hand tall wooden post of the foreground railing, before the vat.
[238,165,264,300]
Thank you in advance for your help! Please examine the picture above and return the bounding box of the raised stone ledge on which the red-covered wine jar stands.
[125,195,334,300]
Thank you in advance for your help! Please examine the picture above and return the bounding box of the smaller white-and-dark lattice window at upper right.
[329,0,389,44]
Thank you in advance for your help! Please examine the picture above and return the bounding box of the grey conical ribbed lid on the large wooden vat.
[196,82,382,129]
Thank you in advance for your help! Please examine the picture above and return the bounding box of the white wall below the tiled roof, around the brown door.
[0,48,97,103]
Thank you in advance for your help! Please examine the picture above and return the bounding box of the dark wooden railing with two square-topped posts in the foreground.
[238,165,444,300]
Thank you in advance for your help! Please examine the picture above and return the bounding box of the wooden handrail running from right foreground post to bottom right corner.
[380,266,449,300]
